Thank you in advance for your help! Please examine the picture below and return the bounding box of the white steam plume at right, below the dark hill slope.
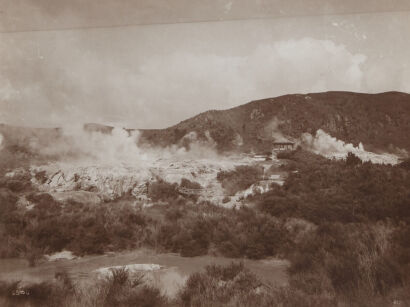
[301,129,399,165]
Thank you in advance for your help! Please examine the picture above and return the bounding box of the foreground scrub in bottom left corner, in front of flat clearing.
[0,268,169,307]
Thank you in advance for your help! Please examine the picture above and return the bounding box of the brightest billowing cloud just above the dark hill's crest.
[245,38,366,96]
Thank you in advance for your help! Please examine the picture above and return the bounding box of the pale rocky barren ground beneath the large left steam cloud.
[27,155,282,206]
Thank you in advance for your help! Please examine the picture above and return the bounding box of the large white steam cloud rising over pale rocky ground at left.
[30,126,221,167]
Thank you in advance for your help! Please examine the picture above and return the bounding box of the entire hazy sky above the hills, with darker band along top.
[0,0,410,128]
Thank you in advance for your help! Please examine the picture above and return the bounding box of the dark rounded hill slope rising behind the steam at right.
[141,92,410,151]
